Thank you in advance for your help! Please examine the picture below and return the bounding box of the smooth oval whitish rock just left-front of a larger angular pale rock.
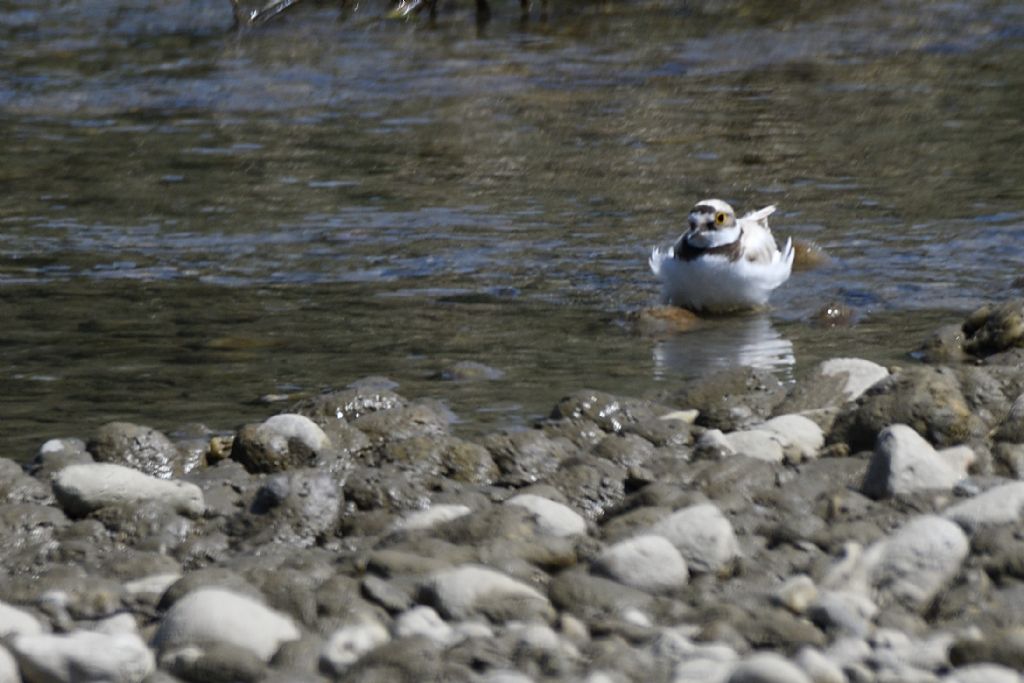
[596,535,690,593]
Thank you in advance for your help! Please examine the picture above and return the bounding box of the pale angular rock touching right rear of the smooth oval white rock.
[648,503,739,573]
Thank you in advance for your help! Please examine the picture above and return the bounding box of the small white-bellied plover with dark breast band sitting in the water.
[648,200,793,312]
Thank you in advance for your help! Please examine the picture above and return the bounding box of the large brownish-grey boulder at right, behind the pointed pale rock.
[829,367,987,451]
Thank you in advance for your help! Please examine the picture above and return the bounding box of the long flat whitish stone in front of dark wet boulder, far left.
[53,463,205,517]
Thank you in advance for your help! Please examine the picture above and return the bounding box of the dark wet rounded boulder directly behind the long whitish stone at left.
[86,422,189,479]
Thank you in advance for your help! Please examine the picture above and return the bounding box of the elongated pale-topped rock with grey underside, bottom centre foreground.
[421,565,554,622]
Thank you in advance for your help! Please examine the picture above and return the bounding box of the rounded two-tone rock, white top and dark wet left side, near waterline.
[231,414,333,472]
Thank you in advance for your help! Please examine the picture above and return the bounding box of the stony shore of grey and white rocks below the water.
[0,300,1024,683]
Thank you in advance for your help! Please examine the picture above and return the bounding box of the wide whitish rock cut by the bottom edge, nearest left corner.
[9,631,157,683]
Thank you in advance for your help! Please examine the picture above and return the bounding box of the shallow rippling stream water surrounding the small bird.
[0,0,1024,459]
